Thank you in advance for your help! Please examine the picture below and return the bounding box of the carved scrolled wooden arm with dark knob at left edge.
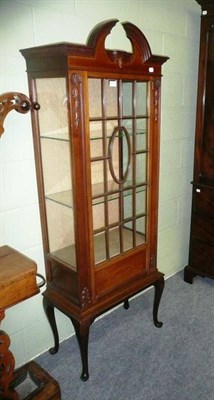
[0,92,40,137]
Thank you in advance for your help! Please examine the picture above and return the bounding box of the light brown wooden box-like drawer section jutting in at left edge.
[0,246,39,310]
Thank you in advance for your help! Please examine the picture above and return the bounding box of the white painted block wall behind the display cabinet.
[0,0,200,366]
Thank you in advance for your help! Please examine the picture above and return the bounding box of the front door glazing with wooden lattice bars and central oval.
[89,78,149,264]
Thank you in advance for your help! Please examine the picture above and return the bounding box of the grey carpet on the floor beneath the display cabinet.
[36,273,214,400]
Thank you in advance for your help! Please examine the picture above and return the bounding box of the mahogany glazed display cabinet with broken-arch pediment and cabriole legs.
[21,19,168,380]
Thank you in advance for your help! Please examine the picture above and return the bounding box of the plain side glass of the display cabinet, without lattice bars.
[36,78,76,268]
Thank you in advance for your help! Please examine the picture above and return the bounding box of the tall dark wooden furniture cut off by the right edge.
[184,0,214,283]
